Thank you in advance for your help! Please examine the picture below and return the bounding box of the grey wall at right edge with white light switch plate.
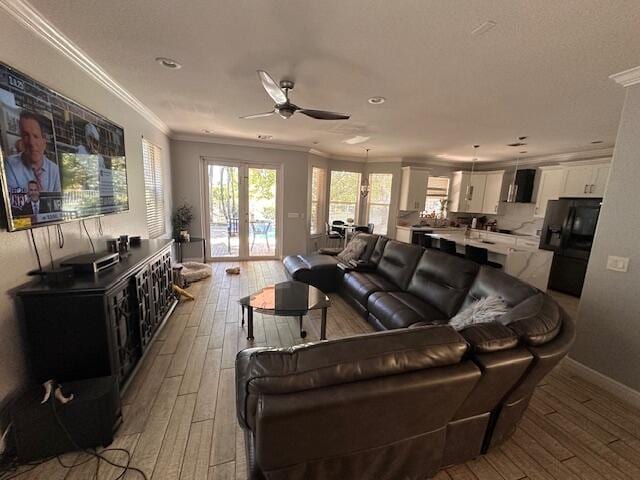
[570,80,640,391]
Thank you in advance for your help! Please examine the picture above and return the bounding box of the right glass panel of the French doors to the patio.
[247,167,278,257]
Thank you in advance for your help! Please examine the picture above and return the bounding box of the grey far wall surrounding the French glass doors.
[171,139,309,256]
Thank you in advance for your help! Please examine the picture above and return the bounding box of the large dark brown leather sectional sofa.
[236,235,575,480]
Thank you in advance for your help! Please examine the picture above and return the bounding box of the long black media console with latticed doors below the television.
[17,240,177,389]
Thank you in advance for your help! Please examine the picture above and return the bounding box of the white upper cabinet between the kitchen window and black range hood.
[448,170,504,214]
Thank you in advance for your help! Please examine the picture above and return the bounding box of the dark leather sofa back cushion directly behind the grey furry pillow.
[461,265,538,308]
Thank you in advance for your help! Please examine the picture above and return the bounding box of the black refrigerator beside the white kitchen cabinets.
[540,198,602,297]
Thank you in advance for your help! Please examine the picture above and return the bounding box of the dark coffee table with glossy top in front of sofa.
[238,281,331,340]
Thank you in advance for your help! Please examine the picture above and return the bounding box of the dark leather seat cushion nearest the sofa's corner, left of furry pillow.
[367,292,447,330]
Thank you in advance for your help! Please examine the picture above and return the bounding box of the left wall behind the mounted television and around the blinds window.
[0,12,171,420]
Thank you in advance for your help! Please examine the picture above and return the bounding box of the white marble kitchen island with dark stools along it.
[428,231,553,291]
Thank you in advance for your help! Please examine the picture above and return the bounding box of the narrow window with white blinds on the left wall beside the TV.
[142,139,165,238]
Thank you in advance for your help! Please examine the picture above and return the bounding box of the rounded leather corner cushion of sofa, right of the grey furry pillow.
[499,293,562,345]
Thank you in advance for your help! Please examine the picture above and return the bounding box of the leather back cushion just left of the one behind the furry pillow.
[407,249,480,318]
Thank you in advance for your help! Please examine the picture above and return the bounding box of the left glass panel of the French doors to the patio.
[207,163,242,258]
